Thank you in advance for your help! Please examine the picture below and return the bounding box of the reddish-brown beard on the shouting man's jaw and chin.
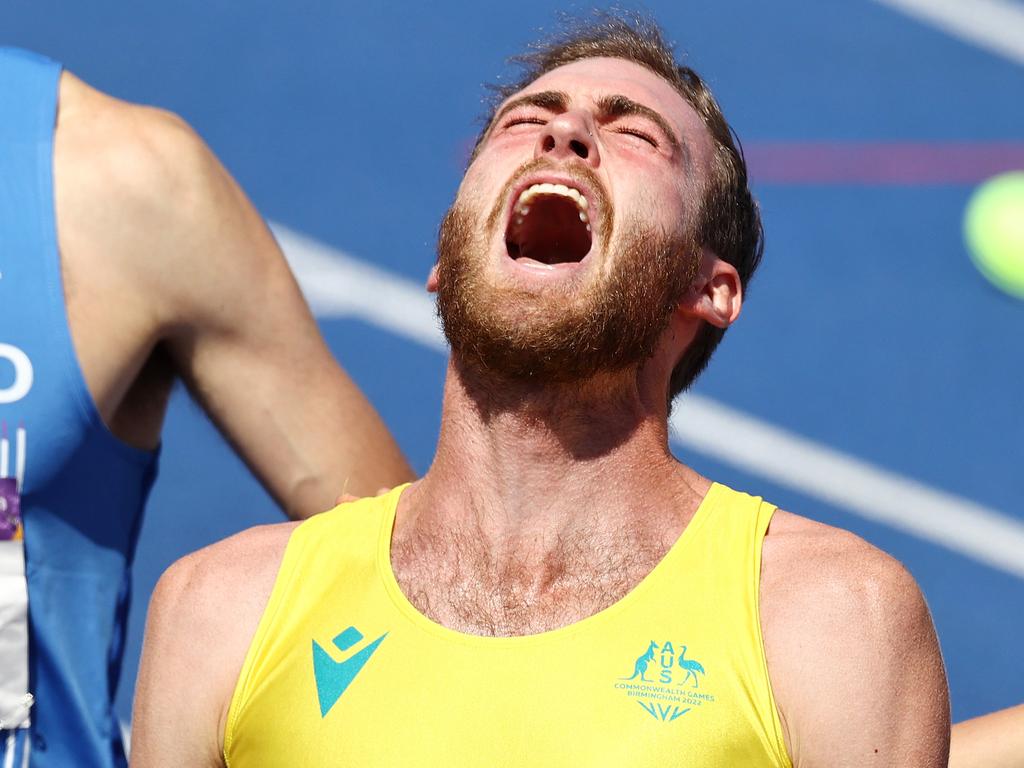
[437,174,699,384]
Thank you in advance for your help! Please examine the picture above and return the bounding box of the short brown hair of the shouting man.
[474,12,764,403]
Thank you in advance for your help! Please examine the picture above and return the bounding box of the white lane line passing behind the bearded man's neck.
[273,224,1024,579]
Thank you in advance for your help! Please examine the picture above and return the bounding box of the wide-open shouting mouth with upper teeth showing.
[505,183,593,266]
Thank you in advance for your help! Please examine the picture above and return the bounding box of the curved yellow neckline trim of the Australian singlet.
[377,482,726,648]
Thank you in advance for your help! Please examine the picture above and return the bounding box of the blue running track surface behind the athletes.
[0,0,1024,719]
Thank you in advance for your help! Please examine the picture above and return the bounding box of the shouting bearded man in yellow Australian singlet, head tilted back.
[133,13,949,768]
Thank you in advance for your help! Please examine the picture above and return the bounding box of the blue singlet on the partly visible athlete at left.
[0,48,157,768]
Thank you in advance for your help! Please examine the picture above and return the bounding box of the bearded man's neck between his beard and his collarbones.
[399,360,707,548]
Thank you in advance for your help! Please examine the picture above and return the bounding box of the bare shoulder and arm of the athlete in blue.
[56,75,412,517]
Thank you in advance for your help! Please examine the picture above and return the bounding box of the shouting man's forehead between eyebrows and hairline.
[509,56,713,163]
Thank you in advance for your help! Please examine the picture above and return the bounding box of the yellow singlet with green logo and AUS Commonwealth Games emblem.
[224,484,791,768]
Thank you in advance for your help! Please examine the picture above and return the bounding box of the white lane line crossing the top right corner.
[874,0,1024,65]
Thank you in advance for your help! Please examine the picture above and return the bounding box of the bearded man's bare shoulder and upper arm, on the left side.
[131,523,296,768]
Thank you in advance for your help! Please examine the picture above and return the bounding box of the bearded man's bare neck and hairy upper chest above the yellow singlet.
[391,354,709,635]
